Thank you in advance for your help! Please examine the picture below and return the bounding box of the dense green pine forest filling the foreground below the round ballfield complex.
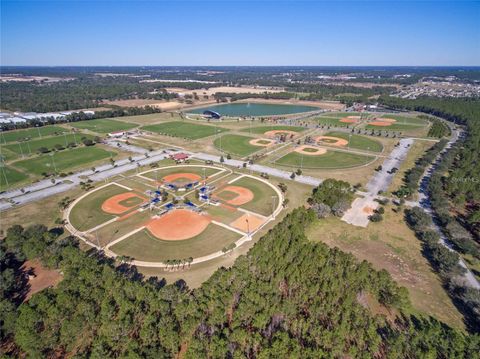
[0,208,480,358]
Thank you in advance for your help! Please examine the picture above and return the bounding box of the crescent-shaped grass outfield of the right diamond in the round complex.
[231,177,279,216]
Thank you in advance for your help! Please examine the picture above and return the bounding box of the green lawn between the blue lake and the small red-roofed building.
[142,121,228,140]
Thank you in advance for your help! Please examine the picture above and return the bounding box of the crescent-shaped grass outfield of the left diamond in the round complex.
[69,184,129,231]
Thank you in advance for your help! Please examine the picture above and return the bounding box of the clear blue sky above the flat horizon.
[0,0,480,66]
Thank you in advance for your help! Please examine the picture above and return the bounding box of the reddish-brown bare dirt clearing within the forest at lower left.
[22,259,62,301]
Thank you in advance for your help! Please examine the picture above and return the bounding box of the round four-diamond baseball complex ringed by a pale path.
[64,164,283,268]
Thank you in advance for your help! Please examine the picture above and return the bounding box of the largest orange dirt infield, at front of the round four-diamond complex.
[147,209,211,241]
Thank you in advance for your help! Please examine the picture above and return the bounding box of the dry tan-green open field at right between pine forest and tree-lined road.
[307,206,464,328]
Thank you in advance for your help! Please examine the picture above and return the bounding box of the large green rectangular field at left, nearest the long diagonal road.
[13,146,116,175]
